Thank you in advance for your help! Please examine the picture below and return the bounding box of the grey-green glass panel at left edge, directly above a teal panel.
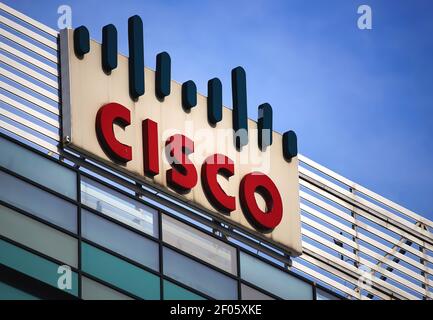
[0,205,78,267]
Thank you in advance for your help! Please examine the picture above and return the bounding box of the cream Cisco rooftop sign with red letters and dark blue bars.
[60,16,301,255]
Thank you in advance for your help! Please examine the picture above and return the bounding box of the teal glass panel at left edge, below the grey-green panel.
[0,240,78,295]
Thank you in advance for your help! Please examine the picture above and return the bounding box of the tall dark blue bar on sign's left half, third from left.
[128,15,144,99]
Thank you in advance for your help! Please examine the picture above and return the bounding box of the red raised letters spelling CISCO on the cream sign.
[96,103,283,232]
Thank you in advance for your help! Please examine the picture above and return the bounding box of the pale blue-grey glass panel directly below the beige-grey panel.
[163,248,237,300]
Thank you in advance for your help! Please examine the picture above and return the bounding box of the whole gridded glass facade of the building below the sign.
[0,136,340,300]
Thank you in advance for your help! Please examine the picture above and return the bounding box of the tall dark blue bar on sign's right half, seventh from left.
[232,67,248,149]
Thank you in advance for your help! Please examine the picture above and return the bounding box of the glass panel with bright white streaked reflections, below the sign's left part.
[81,177,158,237]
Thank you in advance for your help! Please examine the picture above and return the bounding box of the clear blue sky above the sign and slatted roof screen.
[3,0,433,219]
